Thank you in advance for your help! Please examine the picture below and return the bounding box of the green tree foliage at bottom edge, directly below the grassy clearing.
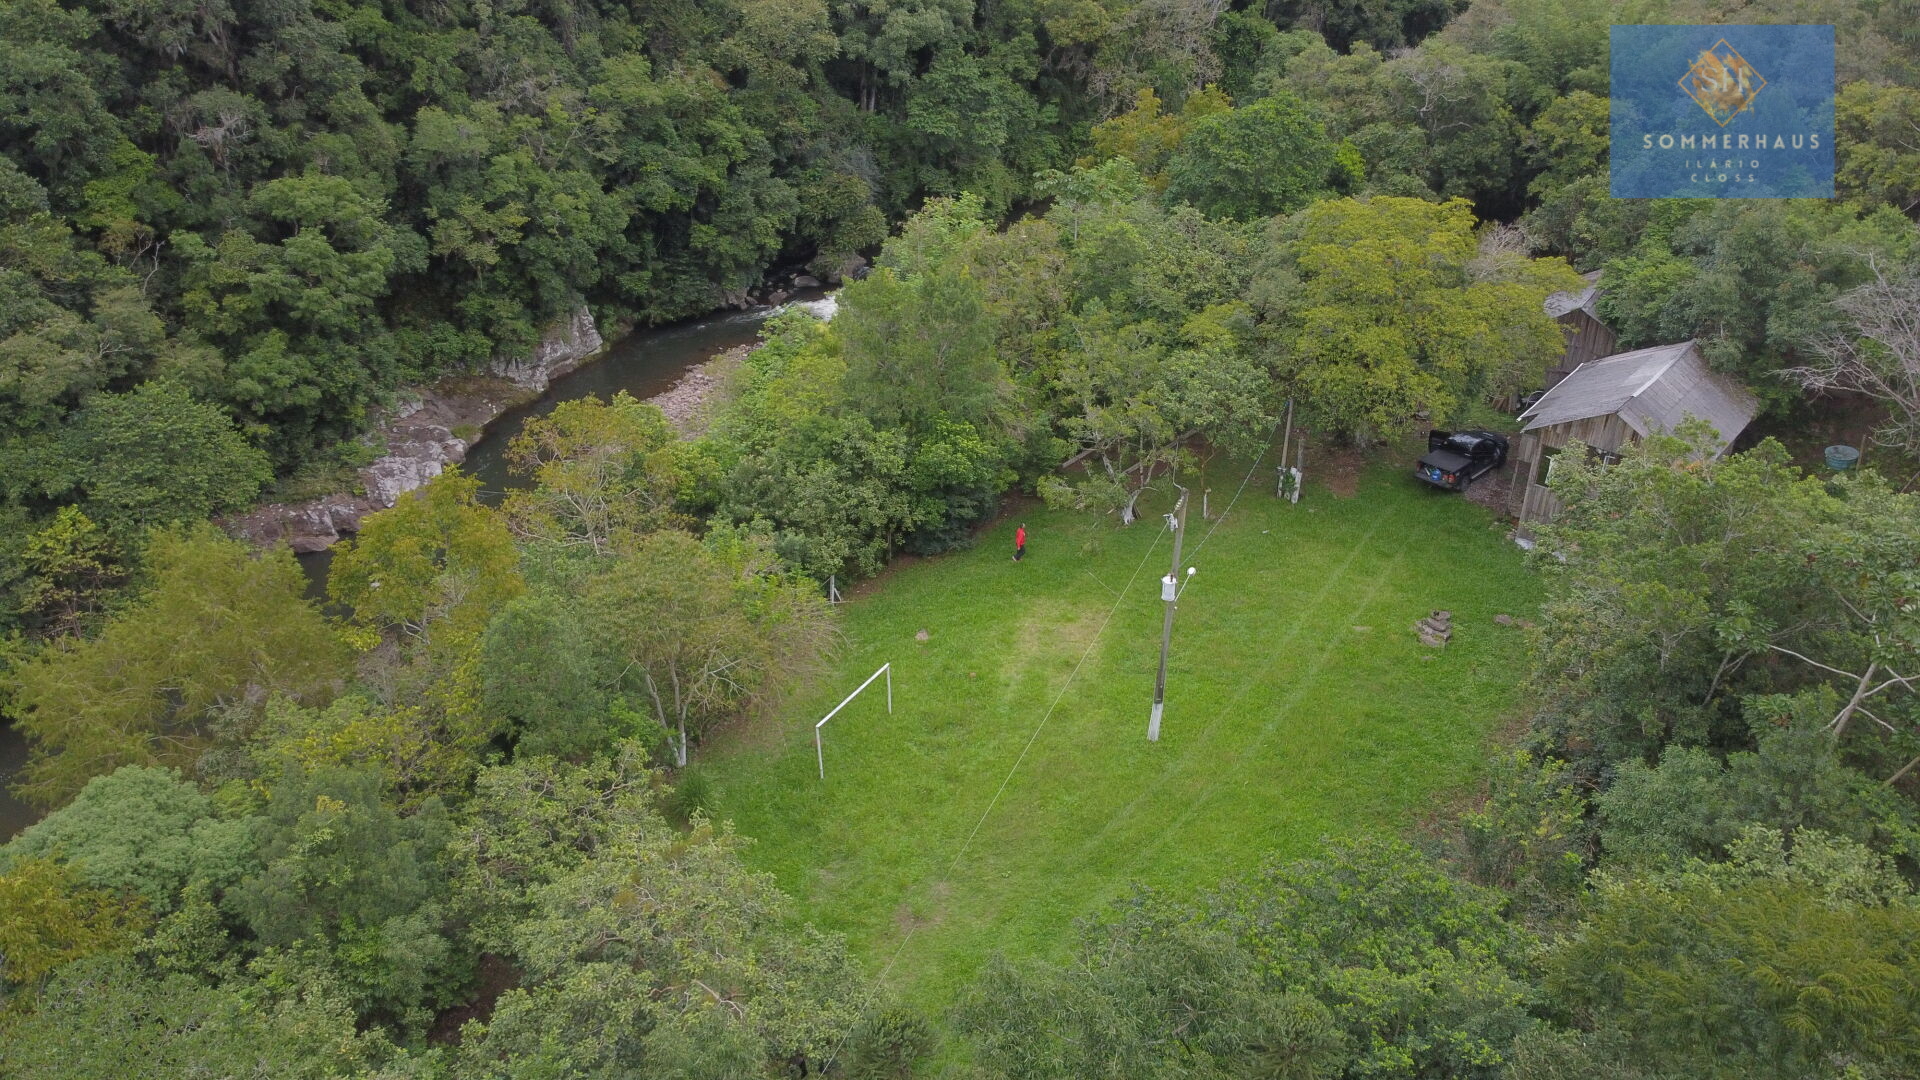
[958,842,1534,1080]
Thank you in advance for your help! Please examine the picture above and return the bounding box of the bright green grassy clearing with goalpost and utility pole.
[699,449,1538,1007]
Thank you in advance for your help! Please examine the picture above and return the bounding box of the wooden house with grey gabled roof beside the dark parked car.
[1507,342,1761,536]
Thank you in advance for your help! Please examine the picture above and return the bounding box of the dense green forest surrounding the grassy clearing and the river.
[0,0,1920,1080]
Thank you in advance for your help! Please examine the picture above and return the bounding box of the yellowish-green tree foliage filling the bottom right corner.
[1548,830,1920,1080]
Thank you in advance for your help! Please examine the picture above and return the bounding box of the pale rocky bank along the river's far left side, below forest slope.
[221,306,607,552]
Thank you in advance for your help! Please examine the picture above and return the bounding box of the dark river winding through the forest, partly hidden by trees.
[0,288,833,826]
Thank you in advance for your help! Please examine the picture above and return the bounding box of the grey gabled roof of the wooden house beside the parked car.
[1521,342,1761,442]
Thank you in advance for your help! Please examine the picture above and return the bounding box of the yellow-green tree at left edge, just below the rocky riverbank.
[10,525,348,805]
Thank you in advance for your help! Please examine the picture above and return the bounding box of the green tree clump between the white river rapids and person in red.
[697,210,1050,580]
